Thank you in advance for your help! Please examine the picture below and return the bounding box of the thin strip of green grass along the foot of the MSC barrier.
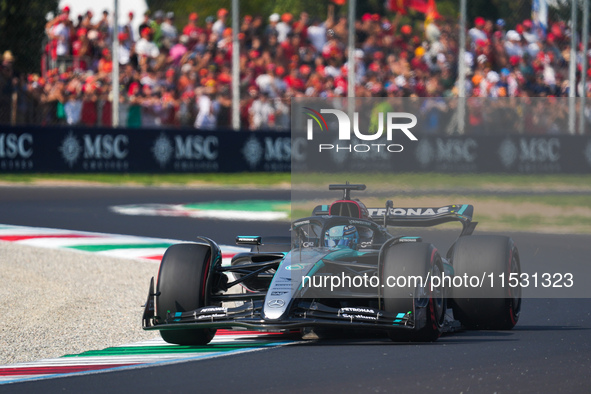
[0,173,591,191]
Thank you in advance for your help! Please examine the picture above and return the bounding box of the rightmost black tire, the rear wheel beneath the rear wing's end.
[452,235,521,330]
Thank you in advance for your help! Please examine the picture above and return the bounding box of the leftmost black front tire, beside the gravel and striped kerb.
[156,243,216,345]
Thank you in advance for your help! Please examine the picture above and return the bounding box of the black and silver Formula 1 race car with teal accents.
[143,183,521,345]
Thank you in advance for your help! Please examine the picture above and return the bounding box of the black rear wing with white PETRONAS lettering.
[367,205,477,235]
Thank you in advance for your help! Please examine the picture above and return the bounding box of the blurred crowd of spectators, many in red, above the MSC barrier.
[0,6,591,130]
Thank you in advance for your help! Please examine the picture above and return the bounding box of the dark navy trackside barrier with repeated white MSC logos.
[0,126,591,174]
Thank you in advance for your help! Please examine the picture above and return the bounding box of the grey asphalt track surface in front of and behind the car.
[0,187,591,393]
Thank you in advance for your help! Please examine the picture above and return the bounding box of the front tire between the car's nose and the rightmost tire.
[382,242,447,342]
